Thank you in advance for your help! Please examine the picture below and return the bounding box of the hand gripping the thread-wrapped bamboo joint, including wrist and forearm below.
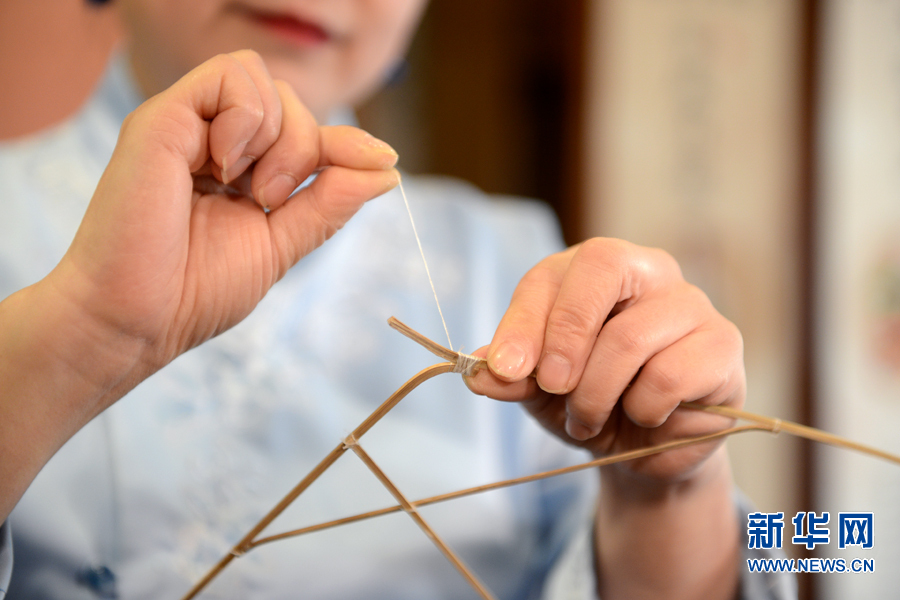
[467,239,746,598]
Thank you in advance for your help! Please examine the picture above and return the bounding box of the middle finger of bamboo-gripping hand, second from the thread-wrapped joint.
[537,238,681,394]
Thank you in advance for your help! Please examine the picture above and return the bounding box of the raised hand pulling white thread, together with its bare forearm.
[0,51,399,520]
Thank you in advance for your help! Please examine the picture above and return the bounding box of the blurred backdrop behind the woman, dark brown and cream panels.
[0,0,900,599]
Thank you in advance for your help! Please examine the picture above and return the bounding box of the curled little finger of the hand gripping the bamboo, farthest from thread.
[622,318,746,427]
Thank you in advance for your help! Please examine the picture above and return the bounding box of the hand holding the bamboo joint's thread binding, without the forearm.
[467,238,746,482]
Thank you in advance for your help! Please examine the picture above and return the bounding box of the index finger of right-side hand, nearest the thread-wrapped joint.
[487,249,574,381]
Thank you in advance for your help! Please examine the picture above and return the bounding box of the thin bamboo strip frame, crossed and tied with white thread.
[182,317,900,600]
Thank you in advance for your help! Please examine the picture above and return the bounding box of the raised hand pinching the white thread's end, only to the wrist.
[49,51,399,390]
